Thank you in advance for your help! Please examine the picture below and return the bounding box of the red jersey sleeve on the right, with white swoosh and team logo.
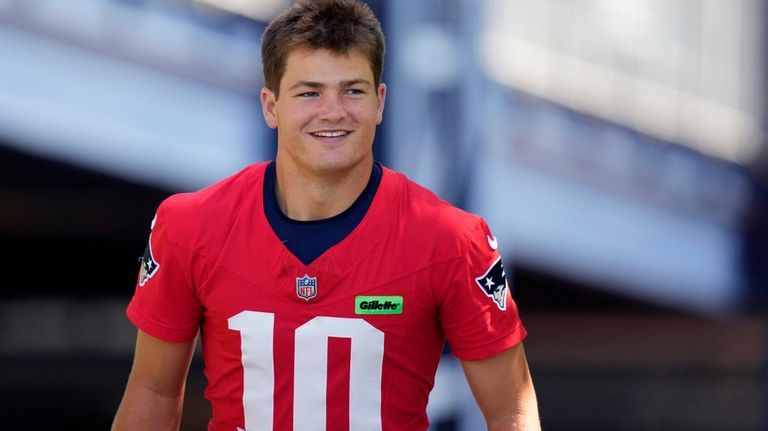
[440,219,526,360]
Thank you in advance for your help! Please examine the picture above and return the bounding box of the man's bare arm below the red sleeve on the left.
[112,330,200,431]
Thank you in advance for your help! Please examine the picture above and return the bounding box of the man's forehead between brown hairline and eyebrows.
[280,48,373,87]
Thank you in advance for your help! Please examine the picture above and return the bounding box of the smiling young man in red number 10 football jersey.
[113,0,539,431]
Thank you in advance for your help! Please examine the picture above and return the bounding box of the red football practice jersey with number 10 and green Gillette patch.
[127,163,526,431]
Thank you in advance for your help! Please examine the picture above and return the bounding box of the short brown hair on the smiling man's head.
[261,0,385,96]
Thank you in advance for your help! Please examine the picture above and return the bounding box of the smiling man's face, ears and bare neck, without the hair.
[261,46,386,220]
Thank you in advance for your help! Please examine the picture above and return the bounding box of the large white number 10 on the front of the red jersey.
[228,311,384,431]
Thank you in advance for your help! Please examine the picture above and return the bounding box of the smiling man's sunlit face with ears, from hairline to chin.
[261,49,386,179]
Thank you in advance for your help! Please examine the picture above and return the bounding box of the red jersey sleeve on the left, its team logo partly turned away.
[126,201,202,342]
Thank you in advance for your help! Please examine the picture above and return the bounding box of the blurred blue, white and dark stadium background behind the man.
[0,0,768,430]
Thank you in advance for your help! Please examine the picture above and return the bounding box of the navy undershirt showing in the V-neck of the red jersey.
[264,161,381,265]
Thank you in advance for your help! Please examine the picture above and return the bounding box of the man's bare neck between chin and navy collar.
[275,155,373,221]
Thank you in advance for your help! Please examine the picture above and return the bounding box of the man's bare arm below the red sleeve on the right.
[461,343,541,431]
